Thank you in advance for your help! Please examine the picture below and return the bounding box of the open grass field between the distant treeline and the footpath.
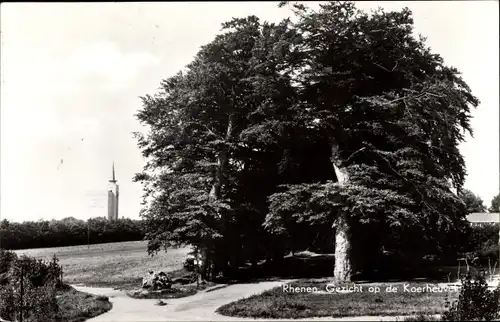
[15,241,190,288]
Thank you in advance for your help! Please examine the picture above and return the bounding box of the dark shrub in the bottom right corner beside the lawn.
[442,273,500,321]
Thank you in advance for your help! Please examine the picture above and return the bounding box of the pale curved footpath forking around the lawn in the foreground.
[73,280,426,322]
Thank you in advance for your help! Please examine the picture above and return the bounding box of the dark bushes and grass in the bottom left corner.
[0,248,111,322]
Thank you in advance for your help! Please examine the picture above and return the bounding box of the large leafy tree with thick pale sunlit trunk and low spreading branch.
[266,2,478,280]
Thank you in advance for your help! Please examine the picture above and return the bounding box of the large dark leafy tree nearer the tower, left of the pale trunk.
[136,17,318,277]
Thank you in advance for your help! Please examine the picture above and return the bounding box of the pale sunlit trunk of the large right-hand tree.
[332,144,353,282]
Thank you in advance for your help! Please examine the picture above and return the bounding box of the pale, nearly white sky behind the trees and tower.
[0,1,500,221]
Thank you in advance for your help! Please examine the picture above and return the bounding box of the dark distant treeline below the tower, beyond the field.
[0,217,144,249]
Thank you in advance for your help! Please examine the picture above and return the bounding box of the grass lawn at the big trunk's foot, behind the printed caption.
[217,279,458,319]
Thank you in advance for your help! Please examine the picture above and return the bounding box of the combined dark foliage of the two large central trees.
[135,2,479,280]
